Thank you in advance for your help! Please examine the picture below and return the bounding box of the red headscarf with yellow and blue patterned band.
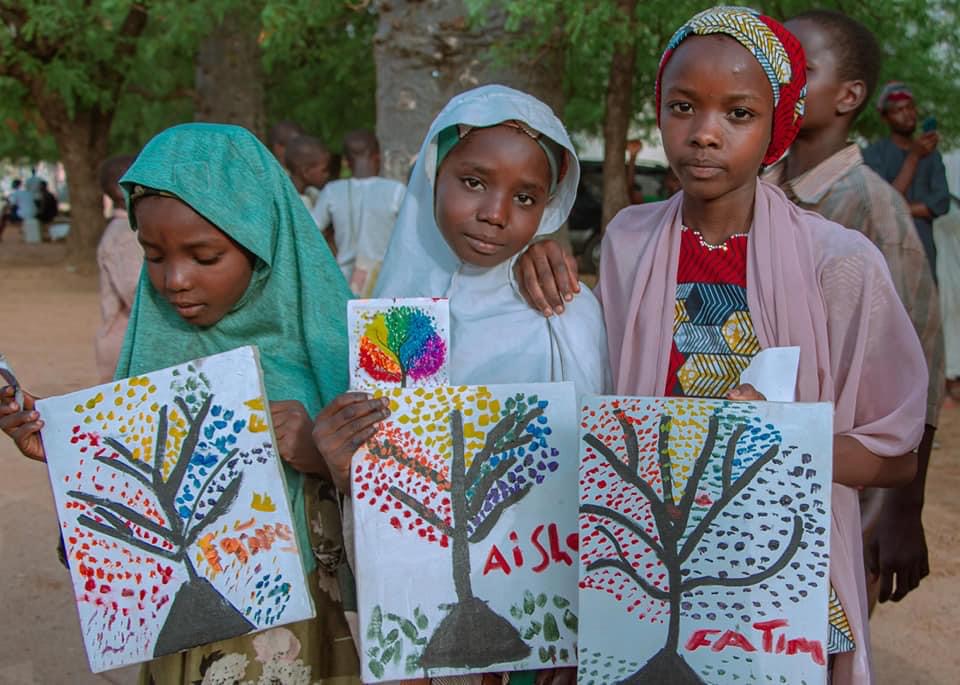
[656,6,807,166]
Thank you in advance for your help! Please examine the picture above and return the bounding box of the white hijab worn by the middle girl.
[376,85,609,393]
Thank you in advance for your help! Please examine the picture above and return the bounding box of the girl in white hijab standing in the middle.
[376,85,609,394]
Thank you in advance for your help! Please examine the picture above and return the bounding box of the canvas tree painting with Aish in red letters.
[352,383,577,682]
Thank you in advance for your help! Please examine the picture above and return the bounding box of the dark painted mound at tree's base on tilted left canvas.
[153,578,256,657]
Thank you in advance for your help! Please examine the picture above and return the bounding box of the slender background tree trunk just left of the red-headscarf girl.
[601,0,637,229]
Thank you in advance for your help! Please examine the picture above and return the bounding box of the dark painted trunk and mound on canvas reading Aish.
[420,410,530,671]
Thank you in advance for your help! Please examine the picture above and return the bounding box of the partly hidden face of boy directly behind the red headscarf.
[786,19,844,133]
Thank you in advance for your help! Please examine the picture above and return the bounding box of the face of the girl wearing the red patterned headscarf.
[660,35,773,200]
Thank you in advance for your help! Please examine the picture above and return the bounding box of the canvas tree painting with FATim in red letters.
[578,397,833,685]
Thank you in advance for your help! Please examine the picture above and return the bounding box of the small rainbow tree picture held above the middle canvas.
[347,298,450,390]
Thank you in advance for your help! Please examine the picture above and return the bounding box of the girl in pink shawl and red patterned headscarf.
[518,7,926,683]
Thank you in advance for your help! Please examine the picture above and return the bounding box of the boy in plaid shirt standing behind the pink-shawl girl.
[764,10,944,601]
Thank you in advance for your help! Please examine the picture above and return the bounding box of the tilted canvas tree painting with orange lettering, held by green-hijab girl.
[38,347,313,672]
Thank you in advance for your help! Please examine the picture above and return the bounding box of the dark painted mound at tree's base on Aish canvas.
[420,598,530,670]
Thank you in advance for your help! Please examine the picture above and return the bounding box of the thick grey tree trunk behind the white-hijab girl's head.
[374,0,564,181]
